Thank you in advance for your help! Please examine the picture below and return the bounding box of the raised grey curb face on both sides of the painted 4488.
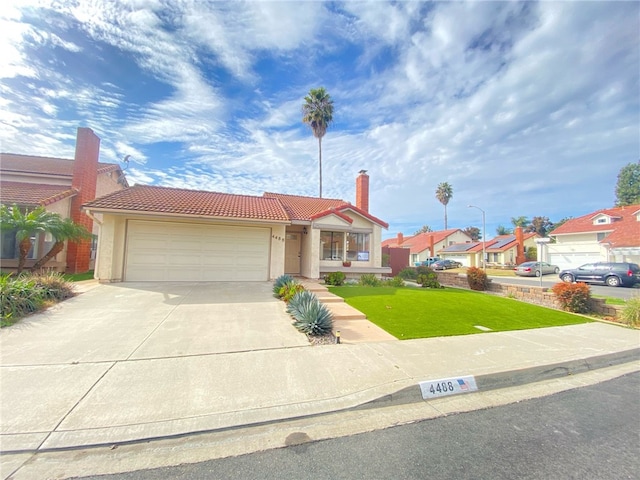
[352,348,640,410]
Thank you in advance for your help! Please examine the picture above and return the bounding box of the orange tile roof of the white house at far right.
[549,204,640,247]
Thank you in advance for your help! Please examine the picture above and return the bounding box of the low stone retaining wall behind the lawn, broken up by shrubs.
[436,271,619,318]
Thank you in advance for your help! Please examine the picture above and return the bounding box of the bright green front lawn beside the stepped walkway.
[330,286,589,340]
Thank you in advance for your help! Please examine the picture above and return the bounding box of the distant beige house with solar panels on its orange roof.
[439,227,538,268]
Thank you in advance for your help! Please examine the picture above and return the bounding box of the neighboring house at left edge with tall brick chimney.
[0,128,127,273]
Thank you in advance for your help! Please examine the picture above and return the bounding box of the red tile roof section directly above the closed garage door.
[84,185,289,221]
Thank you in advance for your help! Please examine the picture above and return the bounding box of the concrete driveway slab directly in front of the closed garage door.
[0,282,308,367]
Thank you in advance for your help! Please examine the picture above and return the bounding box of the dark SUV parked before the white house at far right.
[558,262,640,287]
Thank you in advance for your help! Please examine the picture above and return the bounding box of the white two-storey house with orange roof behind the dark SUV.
[545,204,640,269]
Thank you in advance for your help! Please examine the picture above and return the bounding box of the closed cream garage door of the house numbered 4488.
[125,220,271,282]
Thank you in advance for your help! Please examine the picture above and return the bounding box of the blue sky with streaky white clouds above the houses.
[0,0,640,238]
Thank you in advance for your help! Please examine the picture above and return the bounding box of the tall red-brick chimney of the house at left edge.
[67,128,100,273]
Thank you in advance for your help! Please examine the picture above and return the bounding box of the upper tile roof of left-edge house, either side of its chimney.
[0,153,120,178]
